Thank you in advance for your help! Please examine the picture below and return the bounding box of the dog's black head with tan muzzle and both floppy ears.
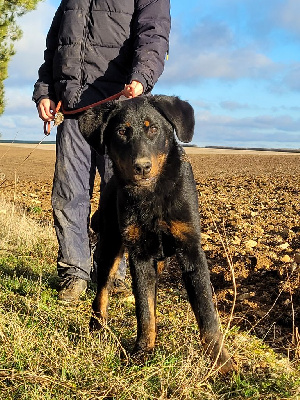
[78,96,195,186]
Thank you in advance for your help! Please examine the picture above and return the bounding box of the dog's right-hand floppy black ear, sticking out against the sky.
[149,95,195,143]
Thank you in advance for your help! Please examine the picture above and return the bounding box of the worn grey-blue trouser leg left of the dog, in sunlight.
[52,118,95,280]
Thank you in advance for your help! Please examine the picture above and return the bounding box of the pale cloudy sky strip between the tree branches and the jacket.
[0,1,55,140]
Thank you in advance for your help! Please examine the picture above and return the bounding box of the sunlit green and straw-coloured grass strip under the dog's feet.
[0,201,300,400]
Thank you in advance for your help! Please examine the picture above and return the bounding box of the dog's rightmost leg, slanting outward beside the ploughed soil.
[177,248,235,373]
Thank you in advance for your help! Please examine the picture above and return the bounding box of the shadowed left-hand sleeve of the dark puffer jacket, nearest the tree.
[32,3,63,104]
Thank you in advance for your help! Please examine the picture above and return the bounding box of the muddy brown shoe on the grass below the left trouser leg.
[58,276,87,303]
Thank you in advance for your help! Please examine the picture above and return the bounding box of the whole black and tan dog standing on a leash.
[79,96,233,372]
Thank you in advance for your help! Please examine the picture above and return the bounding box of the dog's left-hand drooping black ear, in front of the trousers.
[78,102,115,154]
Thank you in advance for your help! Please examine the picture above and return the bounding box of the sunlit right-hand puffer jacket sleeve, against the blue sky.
[131,0,171,93]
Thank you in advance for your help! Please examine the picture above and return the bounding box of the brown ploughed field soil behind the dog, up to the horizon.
[0,145,300,359]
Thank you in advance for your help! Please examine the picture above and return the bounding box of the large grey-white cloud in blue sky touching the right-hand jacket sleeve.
[161,20,284,85]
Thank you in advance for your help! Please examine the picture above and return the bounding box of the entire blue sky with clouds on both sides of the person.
[0,0,300,148]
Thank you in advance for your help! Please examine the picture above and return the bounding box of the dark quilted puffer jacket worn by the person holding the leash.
[33,0,170,108]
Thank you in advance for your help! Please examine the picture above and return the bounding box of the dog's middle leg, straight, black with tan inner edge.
[129,257,157,355]
